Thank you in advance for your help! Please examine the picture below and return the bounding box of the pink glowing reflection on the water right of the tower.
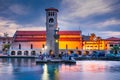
[60,61,106,72]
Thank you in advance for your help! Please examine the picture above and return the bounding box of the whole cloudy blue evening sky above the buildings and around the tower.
[0,0,120,38]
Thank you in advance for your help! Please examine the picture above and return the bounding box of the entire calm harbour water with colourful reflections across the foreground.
[0,58,120,80]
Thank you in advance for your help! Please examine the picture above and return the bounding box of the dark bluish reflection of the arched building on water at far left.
[0,58,40,73]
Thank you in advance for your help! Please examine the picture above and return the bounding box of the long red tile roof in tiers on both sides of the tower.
[14,31,81,42]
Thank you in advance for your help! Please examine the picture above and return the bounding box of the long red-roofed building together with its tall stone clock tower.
[9,8,82,56]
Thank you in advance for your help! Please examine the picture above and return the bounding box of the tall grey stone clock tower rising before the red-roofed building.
[45,8,59,53]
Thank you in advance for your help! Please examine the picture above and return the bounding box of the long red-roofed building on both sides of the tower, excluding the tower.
[10,31,82,56]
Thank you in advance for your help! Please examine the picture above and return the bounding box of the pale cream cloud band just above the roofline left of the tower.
[0,17,45,37]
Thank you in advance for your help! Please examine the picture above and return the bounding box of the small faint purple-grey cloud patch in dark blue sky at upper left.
[9,4,29,15]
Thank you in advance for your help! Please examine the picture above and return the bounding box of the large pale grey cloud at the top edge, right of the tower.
[62,0,112,18]
